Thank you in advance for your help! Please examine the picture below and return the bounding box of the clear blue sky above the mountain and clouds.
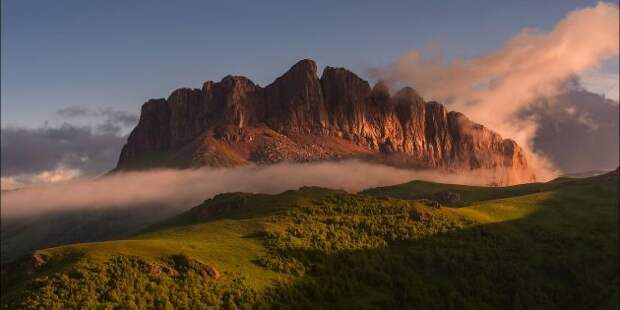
[1,0,618,127]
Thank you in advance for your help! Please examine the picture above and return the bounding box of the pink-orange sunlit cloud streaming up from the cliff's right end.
[373,2,619,175]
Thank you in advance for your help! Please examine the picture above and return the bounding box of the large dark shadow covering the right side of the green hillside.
[266,178,619,309]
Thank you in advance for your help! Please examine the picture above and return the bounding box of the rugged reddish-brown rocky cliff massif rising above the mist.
[117,60,532,183]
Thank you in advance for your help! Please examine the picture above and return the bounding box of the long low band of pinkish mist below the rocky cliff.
[1,160,514,219]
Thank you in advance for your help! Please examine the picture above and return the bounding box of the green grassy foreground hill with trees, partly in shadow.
[2,171,619,309]
